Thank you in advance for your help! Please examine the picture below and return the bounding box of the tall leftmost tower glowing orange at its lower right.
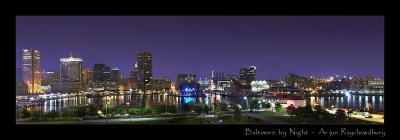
[22,49,41,93]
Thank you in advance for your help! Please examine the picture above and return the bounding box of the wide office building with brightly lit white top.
[60,55,82,83]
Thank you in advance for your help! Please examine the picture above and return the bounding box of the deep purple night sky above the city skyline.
[16,16,384,81]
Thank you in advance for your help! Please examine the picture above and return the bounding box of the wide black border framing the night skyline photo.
[1,3,399,140]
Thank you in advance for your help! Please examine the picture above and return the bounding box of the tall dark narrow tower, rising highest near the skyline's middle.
[136,51,153,93]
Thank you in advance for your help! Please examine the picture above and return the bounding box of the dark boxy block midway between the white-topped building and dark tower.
[93,64,111,82]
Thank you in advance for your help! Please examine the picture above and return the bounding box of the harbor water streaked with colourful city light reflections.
[19,94,384,112]
